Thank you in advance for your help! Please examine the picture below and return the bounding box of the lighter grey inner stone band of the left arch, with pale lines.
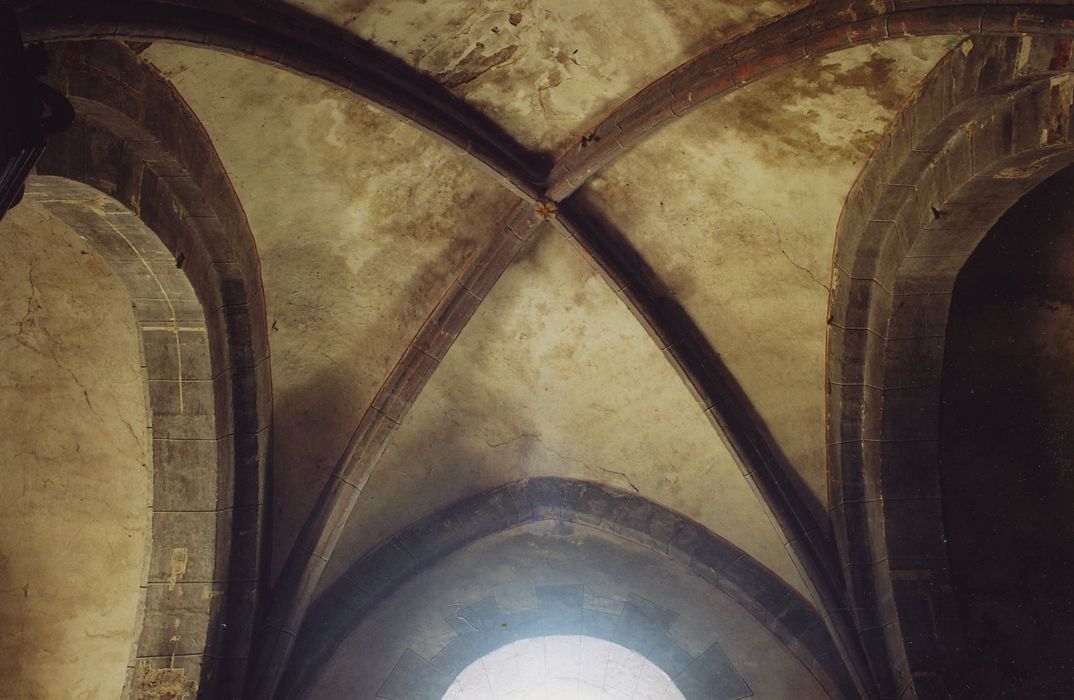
[26,176,222,695]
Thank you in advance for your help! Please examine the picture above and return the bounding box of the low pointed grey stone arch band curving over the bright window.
[278,478,857,699]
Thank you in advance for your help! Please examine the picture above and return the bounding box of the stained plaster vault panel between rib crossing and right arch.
[582,37,950,515]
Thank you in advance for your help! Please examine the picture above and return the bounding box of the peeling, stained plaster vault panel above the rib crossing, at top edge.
[292,0,803,150]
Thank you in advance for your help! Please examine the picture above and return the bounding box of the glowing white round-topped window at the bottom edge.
[444,636,685,700]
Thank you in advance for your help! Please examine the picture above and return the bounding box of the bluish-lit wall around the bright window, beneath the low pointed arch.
[300,520,829,700]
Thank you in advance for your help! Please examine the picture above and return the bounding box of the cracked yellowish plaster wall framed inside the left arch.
[0,202,150,700]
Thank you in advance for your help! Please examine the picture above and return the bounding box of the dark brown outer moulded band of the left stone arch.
[30,42,272,697]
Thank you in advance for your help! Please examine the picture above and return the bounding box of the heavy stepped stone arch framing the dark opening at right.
[827,37,1074,698]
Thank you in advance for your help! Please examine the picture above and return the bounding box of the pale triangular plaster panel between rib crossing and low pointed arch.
[325,229,802,589]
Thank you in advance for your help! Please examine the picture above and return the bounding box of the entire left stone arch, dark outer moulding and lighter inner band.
[28,42,272,697]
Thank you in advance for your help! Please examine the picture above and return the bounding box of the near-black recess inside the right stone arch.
[941,167,1074,698]
